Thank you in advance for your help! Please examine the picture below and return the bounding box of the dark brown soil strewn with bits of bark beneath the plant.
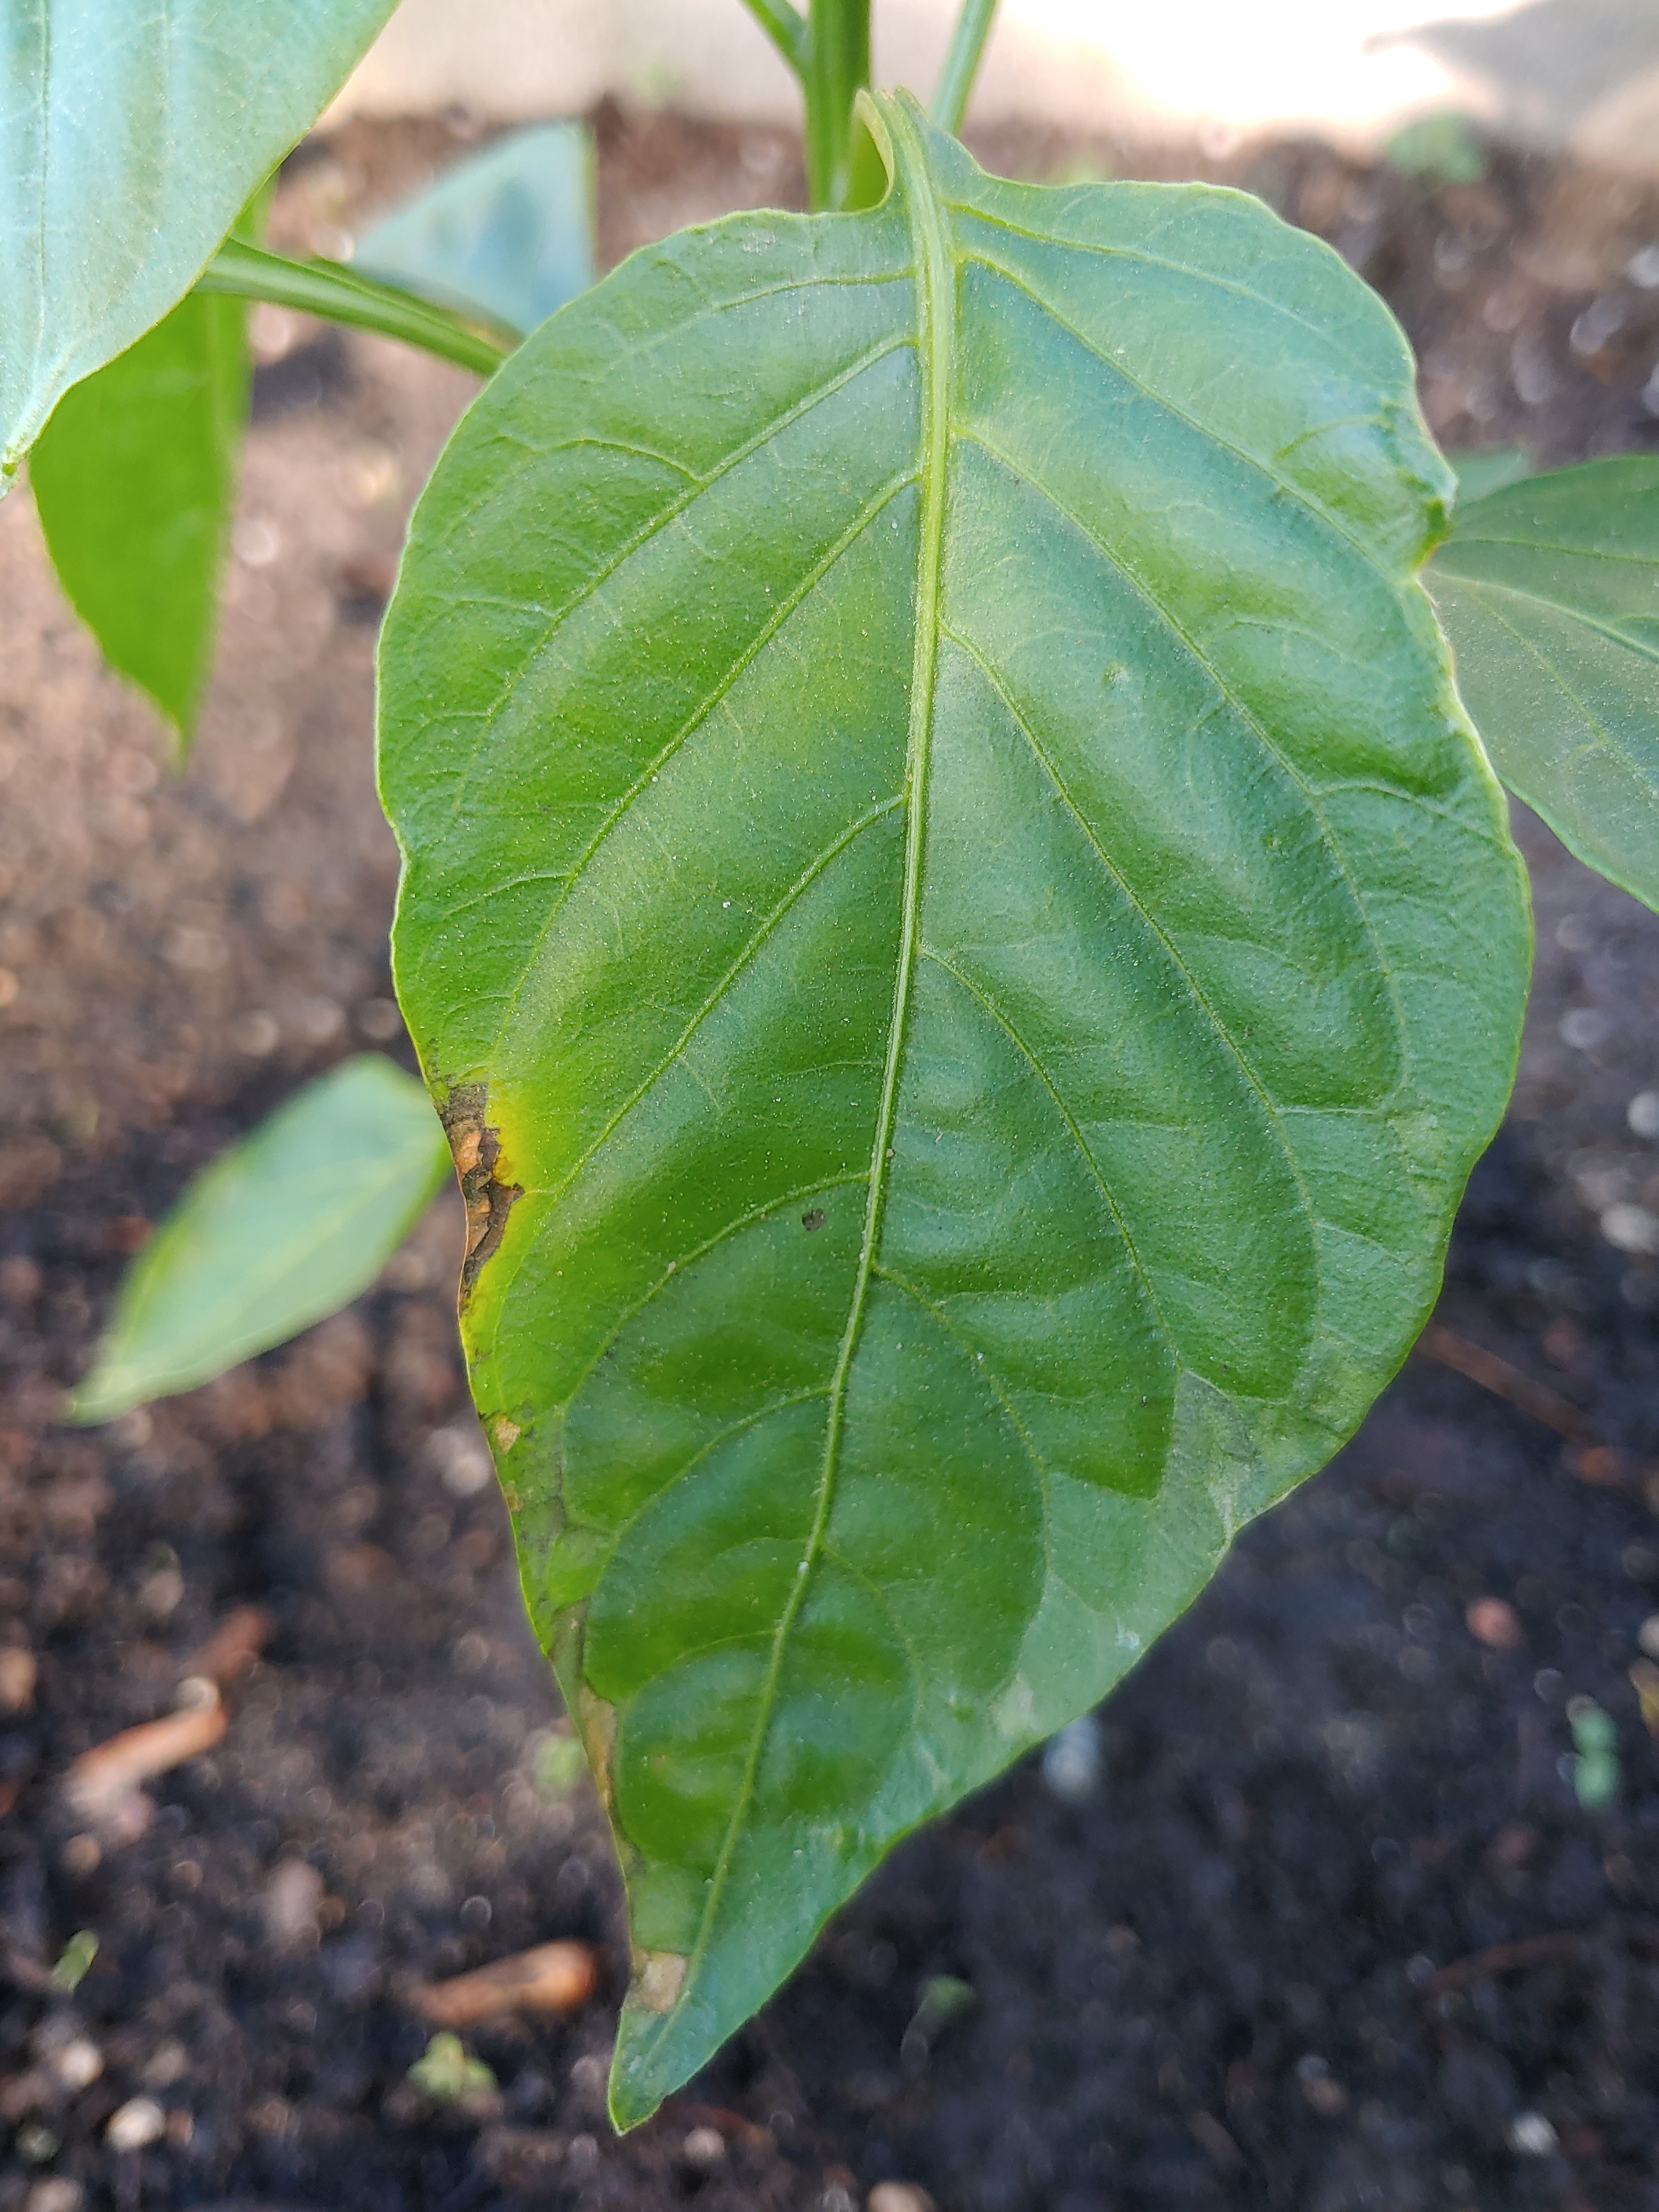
[0,99,1659,2212]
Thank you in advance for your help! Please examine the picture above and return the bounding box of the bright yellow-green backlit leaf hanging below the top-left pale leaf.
[29,276,248,750]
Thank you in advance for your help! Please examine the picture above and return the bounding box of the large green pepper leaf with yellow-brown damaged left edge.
[381,101,1528,2126]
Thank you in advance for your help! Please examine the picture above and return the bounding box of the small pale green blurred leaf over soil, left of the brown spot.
[71,1053,449,1423]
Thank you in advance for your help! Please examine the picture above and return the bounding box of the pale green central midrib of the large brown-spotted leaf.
[654,109,956,2011]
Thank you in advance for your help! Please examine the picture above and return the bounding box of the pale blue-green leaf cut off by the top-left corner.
[0,0,394,489]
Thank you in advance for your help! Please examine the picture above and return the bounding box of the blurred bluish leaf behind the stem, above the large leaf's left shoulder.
[354,124,593,334]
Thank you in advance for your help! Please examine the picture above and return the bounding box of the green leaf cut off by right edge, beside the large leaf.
[1427,456,1659,907]
